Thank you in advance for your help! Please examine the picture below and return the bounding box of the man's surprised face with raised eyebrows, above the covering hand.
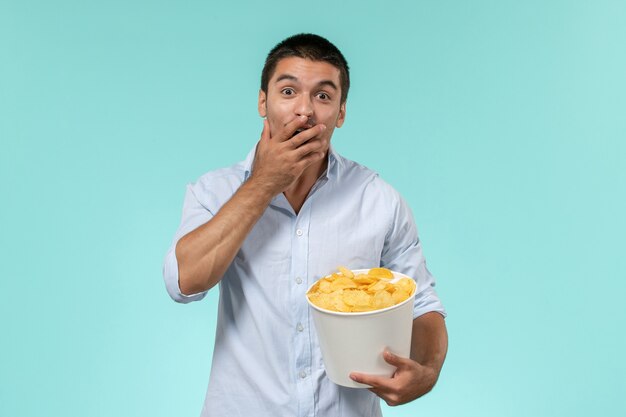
[258,57,346,151]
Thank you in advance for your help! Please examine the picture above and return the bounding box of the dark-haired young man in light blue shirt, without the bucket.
[164,34,447,417]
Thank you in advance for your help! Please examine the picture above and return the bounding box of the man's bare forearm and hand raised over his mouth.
[176,117,325,295]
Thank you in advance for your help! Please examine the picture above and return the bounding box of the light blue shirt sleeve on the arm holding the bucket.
[381,193,447,318]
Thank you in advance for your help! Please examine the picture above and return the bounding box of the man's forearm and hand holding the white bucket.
[350,312,448,406]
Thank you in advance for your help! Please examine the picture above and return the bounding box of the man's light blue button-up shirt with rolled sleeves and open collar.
[163,148,445,417]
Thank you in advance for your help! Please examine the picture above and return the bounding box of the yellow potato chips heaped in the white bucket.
[307,266,415,313]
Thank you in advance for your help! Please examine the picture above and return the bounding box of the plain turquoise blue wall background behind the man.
[0,0,626,417]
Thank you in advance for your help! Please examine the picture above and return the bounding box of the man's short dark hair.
[261,33,350,104]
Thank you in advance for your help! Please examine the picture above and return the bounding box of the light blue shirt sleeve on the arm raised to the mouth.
[163,185,213,304]
